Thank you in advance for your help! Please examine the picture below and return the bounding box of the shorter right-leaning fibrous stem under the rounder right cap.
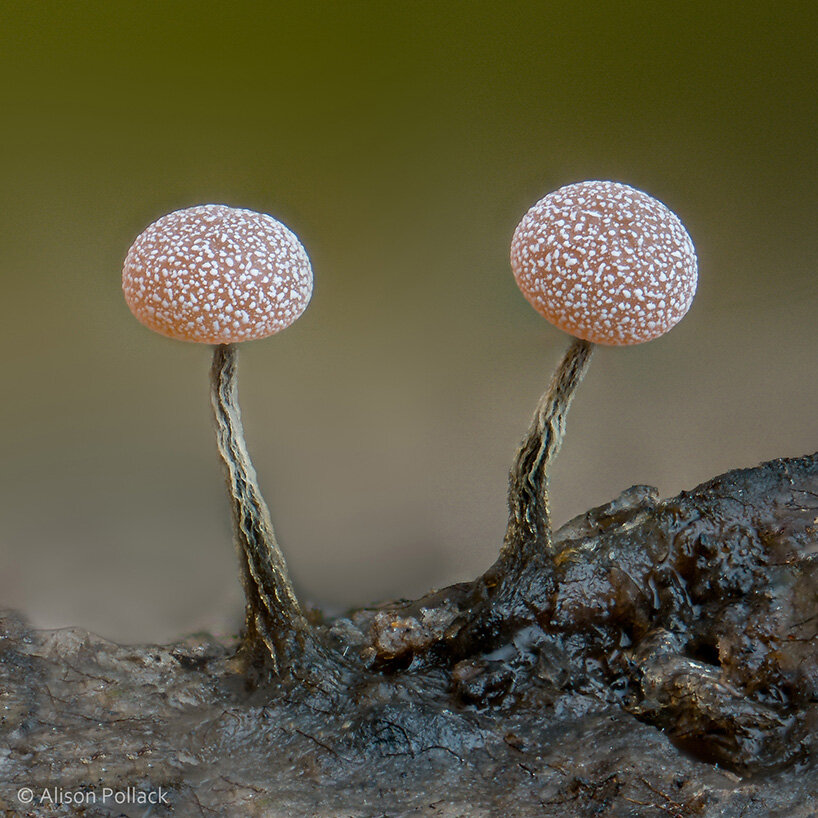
[501,339,594,570]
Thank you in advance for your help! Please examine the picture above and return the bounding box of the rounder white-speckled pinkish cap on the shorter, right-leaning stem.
[511,181,697,346]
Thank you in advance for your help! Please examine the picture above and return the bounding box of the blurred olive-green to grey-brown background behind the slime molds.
[0,0,818,641]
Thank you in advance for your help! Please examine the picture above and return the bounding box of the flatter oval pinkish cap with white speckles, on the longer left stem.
[122,205,312,344]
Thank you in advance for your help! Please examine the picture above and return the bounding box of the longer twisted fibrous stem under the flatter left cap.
[210,344,315,673]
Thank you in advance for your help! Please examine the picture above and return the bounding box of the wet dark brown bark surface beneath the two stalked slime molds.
[0,455,818,818]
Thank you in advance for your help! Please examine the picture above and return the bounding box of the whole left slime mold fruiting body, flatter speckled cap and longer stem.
[122,205,314,672]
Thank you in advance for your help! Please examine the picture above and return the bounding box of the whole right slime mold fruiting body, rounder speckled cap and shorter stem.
[504,181,697,563]
